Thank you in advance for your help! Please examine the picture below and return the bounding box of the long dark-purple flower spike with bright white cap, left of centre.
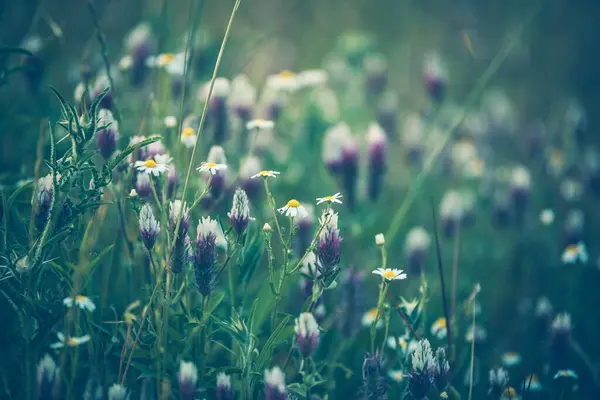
[194,217,220,296]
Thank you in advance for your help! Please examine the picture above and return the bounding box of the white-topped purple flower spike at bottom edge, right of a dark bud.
[407,339,436,400]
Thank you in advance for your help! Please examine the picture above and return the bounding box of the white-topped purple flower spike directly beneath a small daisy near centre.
[317,208,342,287]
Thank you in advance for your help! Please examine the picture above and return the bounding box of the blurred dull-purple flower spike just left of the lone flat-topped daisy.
[337,270,365,338]
